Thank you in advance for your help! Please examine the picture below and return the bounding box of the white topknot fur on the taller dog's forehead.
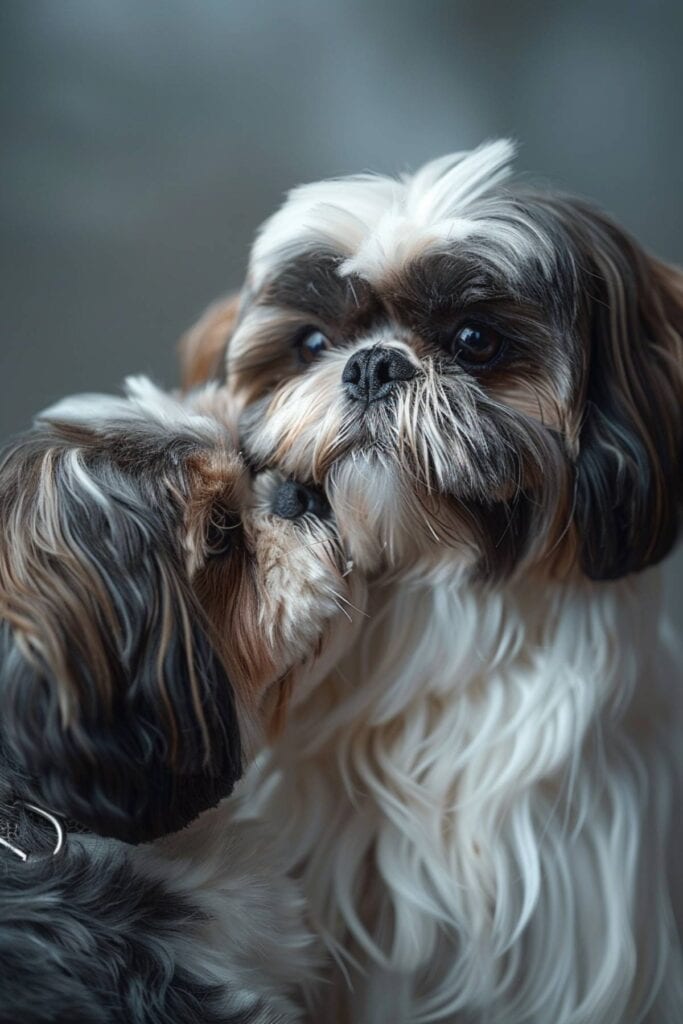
[250,139,515,291]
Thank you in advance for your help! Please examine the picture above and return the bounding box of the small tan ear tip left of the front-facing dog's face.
[179,295,240,391]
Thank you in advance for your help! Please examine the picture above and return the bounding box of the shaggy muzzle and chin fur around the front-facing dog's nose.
[241,332,577,579]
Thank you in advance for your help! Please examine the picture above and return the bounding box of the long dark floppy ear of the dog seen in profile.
[0,429,242,842]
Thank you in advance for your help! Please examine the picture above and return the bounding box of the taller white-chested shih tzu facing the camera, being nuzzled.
[184,141,683,1024]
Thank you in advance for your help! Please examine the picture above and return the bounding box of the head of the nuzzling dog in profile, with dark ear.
[0,380,349,842]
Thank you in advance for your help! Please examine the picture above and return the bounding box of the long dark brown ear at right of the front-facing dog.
[562,201,683,580]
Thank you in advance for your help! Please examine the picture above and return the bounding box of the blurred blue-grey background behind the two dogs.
[0,0,683,622]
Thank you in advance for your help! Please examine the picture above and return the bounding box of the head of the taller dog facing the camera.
[187,142,683,579]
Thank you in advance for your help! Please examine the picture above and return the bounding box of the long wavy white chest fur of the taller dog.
[242,571,683,1024]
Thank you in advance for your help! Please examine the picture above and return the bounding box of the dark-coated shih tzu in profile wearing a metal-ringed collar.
[0,380,360,1024]
